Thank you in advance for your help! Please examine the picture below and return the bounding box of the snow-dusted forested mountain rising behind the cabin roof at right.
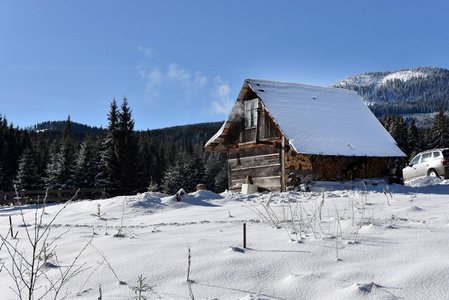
[332,67,449,118]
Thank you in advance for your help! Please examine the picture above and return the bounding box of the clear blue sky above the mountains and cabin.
[0,0,449,130]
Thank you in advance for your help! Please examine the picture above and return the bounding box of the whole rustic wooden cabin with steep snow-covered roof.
[205,79,405,191]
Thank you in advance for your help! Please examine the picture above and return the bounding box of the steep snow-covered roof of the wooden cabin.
[208,79,405,157]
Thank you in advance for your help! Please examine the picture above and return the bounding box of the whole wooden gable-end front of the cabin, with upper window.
[210,88,283,191]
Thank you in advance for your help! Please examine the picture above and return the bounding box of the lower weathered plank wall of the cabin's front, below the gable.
[228,146,281,192]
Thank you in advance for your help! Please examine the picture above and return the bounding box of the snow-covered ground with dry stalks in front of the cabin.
[0,178,449,299]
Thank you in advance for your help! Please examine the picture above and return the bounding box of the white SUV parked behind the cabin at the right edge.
[402,148,449,181]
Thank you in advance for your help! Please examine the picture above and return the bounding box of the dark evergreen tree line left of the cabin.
[0,98,227,196]
